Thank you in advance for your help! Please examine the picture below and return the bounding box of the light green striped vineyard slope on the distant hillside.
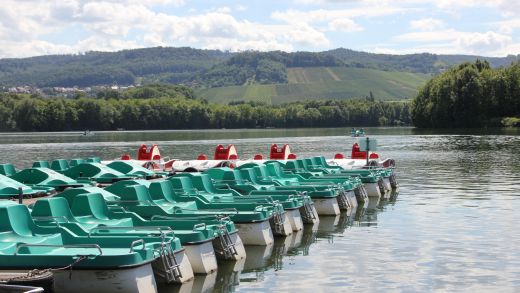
[197,67,429,104]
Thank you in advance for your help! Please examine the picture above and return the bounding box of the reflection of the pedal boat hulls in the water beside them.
[197,193,397,292]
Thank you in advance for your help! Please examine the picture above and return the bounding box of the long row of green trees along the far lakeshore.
[0,86,411,131]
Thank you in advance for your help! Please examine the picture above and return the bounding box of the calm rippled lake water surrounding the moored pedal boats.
[0,128,520,292]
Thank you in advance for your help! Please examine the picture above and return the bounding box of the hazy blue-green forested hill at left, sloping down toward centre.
[0,47,231,87]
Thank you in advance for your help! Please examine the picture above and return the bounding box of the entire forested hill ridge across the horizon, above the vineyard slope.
[0,47,517,88]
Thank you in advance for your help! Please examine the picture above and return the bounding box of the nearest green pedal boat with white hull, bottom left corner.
[0,201,193,292]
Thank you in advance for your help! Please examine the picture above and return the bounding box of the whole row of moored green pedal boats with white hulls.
[0,152,398,292]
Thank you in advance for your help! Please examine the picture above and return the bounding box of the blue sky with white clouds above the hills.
[0,0,520,58]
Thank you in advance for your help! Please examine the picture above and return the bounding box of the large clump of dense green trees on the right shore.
[412,60,520,127]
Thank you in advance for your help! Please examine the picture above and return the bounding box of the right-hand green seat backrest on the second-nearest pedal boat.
[72,193,109,220]
